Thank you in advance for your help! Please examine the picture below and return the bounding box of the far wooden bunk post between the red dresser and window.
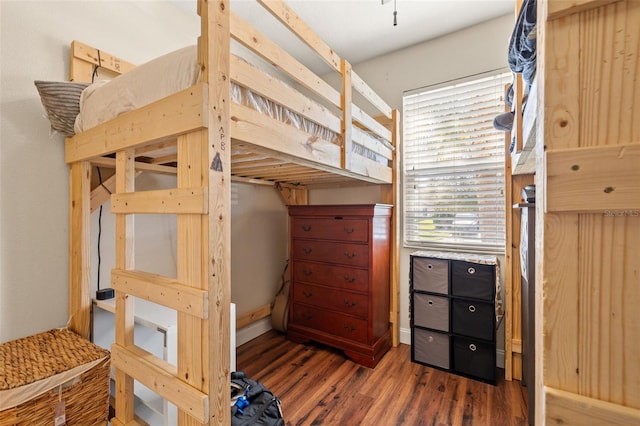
[381,109,401,347]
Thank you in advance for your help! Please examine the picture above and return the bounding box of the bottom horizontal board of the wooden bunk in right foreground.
[544,387,640,426]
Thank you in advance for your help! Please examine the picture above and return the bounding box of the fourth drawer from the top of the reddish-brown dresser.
[293,283,369,318]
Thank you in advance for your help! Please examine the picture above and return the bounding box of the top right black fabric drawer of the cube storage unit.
[451,260,496,301]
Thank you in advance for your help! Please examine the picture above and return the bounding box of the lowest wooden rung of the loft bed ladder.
[111,343,209,423]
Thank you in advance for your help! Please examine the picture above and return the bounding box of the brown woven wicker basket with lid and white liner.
[0,329,110,426]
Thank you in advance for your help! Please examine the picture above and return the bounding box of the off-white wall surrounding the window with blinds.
[310,15,514,354]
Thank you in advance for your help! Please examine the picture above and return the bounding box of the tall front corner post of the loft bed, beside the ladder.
[198,0,231,426]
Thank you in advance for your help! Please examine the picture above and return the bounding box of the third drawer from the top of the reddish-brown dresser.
[293,262,369,292]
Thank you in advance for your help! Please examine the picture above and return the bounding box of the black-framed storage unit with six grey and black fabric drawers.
[410,252,497,384]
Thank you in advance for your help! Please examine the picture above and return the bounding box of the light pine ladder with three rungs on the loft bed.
[111,130,209,425]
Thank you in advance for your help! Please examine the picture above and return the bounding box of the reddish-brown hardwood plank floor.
[237,331,527,426]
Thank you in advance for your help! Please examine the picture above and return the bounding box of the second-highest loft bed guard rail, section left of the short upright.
[231,13,340,107]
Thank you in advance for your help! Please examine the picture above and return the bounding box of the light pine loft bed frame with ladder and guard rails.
[65,0,399,425]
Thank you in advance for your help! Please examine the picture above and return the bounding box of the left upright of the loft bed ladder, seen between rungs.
[115,150,135,424]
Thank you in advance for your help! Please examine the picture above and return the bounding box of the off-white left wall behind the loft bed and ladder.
[0,0,288,342]
